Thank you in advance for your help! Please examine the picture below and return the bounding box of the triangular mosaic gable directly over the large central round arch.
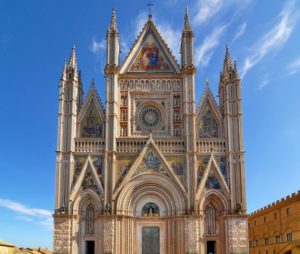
[114,137,186,196]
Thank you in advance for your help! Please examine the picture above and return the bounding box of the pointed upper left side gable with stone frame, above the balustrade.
[77,83,105,137]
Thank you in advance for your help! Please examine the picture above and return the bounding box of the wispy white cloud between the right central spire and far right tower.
[195,25,227,66]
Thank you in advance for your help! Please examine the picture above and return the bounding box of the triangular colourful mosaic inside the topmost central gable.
[130,33,171,72]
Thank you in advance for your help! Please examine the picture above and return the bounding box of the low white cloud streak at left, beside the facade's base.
[0,198,53,229]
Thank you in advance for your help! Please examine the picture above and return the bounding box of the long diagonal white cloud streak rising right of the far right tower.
[241,2,295,78]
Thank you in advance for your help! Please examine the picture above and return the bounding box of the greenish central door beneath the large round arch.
[142,227,160,254]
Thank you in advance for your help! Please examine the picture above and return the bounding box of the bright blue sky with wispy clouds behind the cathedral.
[0,0,300,248]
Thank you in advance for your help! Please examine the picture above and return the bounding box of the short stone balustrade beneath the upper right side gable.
[196,138,226,153]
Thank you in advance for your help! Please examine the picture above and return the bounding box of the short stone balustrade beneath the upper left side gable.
[75,138,105,153]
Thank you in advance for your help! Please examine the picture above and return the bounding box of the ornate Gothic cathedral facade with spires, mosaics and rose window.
[54,7,248,254]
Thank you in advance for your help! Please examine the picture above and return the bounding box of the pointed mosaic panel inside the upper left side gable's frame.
[81,101,103,138]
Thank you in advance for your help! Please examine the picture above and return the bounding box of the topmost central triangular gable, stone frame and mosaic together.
[121,19,180,73]
